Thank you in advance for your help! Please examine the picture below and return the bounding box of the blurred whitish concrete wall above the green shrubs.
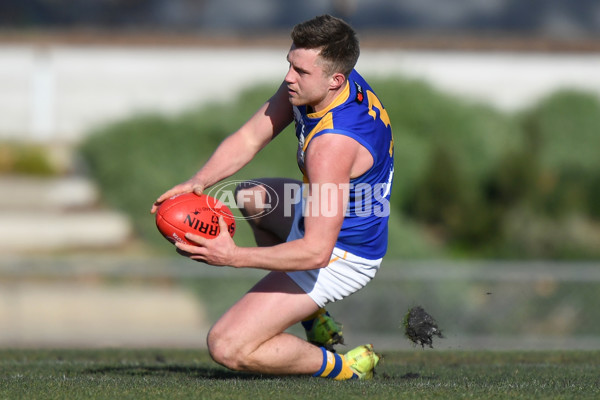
[0,44,600,143]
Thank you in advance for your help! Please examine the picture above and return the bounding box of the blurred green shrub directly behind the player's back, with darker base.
[373,76,522,245]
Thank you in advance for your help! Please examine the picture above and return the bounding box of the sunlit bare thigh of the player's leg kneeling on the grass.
[211,272,319,351]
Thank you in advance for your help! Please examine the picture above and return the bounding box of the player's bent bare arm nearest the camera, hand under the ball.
[177,135,360,271]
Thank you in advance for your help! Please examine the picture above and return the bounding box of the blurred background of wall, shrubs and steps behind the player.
[0,0,600,349]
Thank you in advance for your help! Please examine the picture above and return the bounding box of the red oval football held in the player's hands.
[156,193,235,244]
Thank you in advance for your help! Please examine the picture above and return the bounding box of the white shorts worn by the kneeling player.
[287,199,382,307]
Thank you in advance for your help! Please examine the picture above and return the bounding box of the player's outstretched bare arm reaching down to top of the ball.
[151,83,293,213]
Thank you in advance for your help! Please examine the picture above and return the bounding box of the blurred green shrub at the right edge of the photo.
[490,91,600,259]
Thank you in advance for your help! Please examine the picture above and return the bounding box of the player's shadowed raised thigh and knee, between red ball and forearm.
[236,178,302,242]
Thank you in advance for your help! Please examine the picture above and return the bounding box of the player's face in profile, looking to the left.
[285,45,331,111]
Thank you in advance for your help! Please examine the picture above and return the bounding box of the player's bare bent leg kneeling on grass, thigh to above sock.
[208,272,323,374]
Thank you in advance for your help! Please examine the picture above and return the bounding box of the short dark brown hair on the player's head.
[291,15,360,78]
